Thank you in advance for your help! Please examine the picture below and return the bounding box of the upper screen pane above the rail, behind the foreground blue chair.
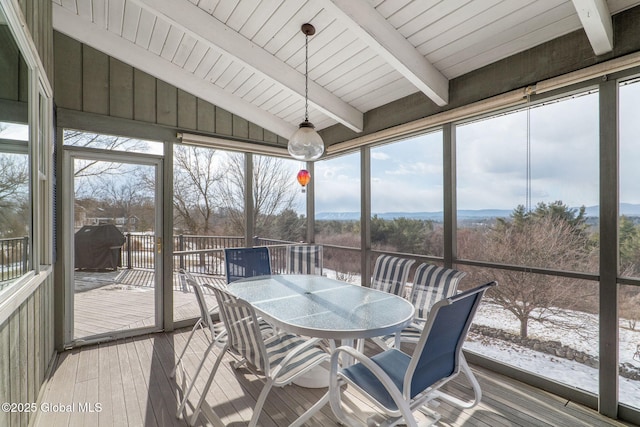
[456,93,599,272]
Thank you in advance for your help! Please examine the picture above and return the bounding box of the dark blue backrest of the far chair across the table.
[224,246,271,283]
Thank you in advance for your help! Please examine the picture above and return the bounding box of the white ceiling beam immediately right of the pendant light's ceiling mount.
[324,0,449,106]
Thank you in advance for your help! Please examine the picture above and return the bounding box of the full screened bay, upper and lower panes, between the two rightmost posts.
[456,93,599,394]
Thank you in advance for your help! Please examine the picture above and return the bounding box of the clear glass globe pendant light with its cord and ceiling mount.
[287,24,324,162]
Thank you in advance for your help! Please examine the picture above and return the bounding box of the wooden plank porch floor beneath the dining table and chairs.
[33,330,628,427]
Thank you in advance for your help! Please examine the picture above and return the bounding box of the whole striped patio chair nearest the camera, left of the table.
[189,287,330,427]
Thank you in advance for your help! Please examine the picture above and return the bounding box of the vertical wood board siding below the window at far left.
[0,275,55,427]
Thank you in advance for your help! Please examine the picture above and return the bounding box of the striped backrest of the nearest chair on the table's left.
[209,285,269,375]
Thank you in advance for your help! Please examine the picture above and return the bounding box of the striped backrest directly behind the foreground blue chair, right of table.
[409,263,467,319]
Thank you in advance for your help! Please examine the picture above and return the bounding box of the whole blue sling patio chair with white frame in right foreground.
[329,282,496,427]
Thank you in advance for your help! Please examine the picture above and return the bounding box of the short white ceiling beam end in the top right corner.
[572,0,613,55]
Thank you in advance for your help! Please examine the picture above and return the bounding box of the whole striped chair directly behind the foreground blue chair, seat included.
[373,263,467,348]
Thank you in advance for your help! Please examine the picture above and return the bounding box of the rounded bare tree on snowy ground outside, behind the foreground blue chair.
[467,205,594,338]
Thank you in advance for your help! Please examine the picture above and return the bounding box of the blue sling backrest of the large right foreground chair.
[403,282,496,398]
